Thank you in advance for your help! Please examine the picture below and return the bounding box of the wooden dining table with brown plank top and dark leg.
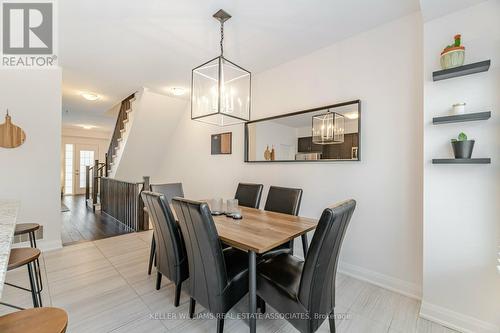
[213,206,318,333]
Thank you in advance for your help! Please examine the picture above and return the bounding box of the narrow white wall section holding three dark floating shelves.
[421,0,500,333]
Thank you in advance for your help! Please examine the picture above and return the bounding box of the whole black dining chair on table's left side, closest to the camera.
[172,198,248,333]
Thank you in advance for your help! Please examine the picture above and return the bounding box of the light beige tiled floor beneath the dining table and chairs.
[0,231,455,333]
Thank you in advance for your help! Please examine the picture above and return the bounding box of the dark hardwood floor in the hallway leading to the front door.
[61,195,131,245]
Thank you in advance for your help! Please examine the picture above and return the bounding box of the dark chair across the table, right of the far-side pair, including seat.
[264,186,302,257]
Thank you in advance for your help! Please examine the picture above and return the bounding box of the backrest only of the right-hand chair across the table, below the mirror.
[264,186,302,215]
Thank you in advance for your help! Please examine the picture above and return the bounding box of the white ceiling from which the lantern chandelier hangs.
[58,0,419,130]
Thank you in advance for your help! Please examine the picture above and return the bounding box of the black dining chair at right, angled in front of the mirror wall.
[257,200,356,333]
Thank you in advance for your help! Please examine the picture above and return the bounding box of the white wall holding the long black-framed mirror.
[153,13,422,297]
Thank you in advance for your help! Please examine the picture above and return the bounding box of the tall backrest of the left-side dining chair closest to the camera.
[172,198,228,313]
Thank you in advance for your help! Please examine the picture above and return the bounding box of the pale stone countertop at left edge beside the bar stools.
[0,200,19,298]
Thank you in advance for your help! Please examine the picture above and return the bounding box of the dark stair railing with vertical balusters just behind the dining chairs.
[100,177,149,231]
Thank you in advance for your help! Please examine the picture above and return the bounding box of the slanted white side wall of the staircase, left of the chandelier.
[114,88,188,182]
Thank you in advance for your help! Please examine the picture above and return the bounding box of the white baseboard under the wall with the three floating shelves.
[420,301,500,333]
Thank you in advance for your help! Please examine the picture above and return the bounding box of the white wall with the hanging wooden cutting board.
[0,68,61,249]
